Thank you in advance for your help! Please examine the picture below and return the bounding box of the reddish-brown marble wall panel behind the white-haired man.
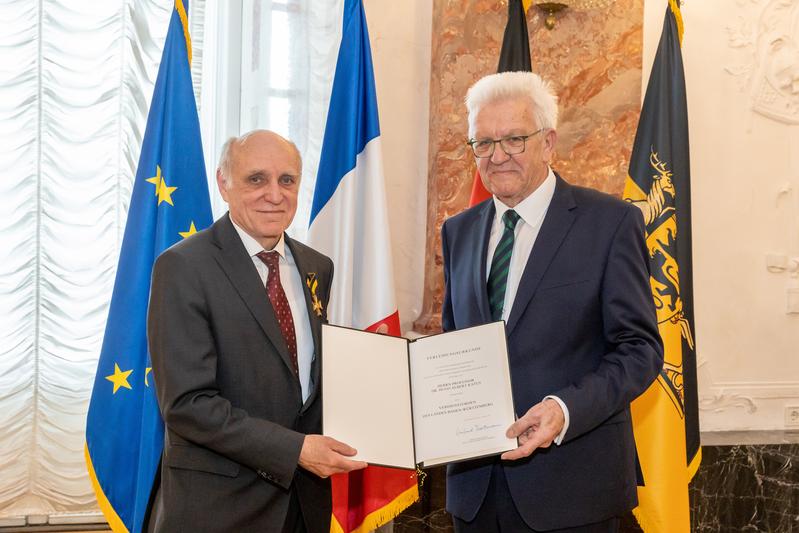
[414,0,643,332]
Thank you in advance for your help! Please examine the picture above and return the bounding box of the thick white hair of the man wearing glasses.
[466,72,558,137]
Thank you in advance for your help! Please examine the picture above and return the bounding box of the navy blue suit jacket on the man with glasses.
[442,177,663,530]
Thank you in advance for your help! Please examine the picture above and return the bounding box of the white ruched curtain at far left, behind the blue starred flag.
[0,0,204,525]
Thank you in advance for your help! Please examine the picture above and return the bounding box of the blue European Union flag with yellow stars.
[85,0,212,533]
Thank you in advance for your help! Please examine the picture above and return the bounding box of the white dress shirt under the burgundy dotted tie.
[230,218,314,402]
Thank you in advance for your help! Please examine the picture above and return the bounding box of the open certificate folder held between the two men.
[322,322,517,468]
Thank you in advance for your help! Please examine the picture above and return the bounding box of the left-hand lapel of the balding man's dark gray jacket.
[214,215,299,378]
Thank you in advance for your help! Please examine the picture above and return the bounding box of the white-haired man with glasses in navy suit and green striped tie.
[442,72,663,533]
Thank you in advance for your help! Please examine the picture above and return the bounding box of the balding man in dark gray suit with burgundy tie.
[147,130,366,533]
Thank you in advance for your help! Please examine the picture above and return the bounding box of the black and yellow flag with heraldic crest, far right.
[624,0,701,533]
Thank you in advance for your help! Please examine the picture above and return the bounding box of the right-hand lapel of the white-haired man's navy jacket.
[508,175,577,335]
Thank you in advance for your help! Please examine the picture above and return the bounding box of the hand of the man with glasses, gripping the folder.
[502,398,565,461]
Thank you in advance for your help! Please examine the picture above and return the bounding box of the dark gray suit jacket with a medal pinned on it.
[147,215,333,533]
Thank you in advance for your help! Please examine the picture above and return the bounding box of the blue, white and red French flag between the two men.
[308,0,418,533]
